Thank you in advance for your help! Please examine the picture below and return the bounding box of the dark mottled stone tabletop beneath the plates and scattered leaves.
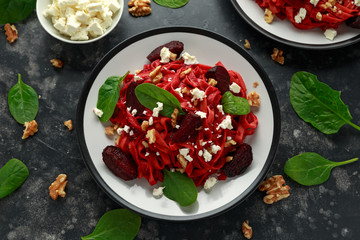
[0,0,360,240]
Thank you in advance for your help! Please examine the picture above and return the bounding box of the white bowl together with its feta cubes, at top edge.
[36,0,124,44]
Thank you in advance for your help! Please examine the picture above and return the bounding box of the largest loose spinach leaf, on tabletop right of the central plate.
[290,72,360,134]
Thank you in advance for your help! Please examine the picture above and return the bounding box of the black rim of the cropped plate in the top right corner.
[230,0,360,50]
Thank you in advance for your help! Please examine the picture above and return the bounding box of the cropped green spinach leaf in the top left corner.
[0,0,36,24]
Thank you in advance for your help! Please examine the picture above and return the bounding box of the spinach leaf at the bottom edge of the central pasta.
[162,169,197,207]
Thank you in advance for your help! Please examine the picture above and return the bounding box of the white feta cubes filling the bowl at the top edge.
[43,0,121,41]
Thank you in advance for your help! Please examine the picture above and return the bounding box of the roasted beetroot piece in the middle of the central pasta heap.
[171,113,202,143]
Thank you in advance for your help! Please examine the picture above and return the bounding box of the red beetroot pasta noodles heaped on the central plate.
[110,57,258,186]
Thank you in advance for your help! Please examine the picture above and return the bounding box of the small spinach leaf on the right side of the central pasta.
[221,91,250,115]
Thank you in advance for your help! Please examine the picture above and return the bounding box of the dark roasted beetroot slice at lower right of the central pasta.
[222,143,253,177]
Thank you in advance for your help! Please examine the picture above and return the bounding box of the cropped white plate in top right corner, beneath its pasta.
[231,0,360,49]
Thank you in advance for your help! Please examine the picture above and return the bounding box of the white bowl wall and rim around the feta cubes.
[36,0,124,44]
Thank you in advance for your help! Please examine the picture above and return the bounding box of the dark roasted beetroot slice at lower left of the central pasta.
[102,146,138,181]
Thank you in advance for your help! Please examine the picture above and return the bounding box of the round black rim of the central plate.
[76,26,281,222]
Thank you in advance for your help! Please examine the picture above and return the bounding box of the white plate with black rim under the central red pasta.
[76,27,280,221]
